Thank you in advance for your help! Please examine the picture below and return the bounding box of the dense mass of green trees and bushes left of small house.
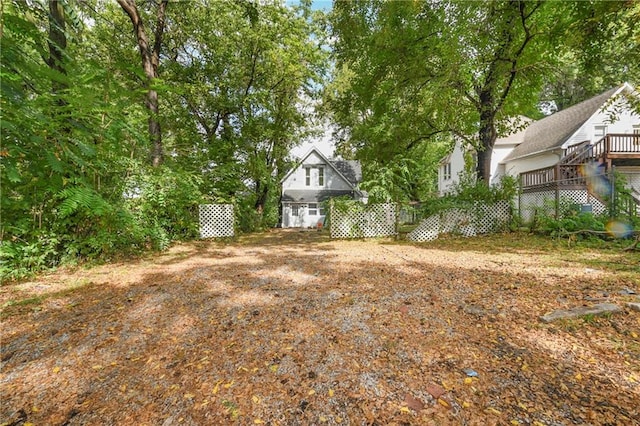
[0,0,327,279]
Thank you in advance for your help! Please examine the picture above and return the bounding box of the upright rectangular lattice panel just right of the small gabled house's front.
[330,203,397,238]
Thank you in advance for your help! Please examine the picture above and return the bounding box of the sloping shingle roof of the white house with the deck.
[503,84,628,162]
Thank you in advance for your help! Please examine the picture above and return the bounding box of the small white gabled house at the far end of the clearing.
[281,148,366,228]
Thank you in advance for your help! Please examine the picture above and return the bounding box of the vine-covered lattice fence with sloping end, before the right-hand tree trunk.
[407,201,511,242]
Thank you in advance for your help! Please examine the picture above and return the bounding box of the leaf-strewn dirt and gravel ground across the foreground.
[0,230,640,425]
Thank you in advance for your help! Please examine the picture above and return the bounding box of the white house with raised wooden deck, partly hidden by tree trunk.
[438,83,640,195]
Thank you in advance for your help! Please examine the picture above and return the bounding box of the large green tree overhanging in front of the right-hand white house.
[326,0,637,181]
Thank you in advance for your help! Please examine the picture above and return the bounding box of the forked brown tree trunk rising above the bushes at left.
[117,0,169,167]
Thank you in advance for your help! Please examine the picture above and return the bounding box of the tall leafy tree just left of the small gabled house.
[159,2,327,224]
